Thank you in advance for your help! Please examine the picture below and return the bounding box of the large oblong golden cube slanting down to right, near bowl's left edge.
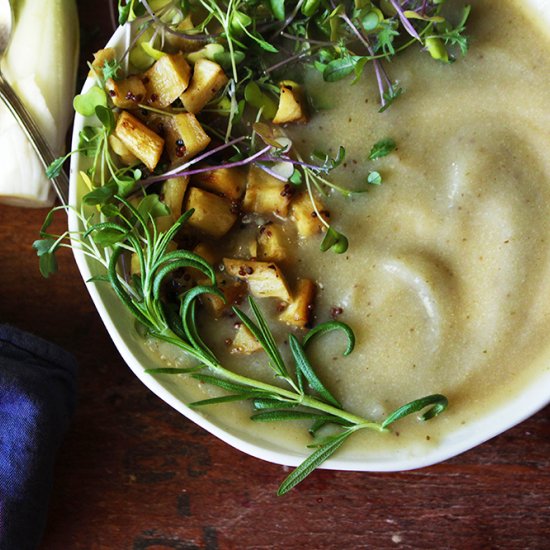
[115,111,164,171]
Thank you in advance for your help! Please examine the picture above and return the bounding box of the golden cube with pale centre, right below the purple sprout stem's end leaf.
[243,166,293,218]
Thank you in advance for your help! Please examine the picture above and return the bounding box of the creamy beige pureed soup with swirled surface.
[154,0,550,457]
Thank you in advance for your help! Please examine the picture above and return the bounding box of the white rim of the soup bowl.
[68,26,550,472]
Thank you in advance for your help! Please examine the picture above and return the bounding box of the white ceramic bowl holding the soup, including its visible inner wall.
[69,20,550,471]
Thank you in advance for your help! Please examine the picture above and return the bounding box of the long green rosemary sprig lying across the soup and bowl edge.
[34,203,447,495]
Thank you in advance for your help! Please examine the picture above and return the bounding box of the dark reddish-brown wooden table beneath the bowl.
[0,0,550,550]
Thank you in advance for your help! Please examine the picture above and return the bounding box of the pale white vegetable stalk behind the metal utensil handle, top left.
[0,0,79,208]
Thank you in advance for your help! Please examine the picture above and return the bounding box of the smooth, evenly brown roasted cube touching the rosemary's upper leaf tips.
[185,187,237,239]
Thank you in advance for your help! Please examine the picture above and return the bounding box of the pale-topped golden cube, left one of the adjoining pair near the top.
[143,52,191,108]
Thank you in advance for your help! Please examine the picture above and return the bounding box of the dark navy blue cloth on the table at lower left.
[0,325,76,550]
